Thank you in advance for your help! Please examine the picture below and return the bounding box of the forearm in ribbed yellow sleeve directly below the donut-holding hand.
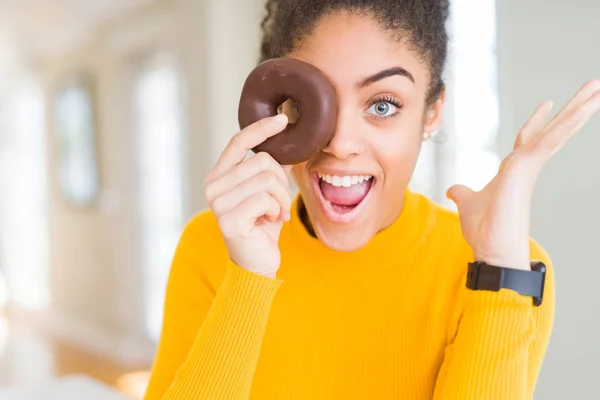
[158,264,281,400]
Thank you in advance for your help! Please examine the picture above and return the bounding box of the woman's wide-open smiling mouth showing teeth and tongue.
[314,173,375,222]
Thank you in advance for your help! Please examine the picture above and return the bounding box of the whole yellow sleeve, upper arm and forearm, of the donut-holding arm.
[145,217,281,400]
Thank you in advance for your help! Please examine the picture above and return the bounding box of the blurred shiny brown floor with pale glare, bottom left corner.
[0,315,149,399]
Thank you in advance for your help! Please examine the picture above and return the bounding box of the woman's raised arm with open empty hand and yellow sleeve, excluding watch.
[435,81,600,400]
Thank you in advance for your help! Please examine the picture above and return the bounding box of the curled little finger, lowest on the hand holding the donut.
[218,192,280,238]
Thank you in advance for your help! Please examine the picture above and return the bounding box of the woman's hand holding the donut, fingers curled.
[204,114,292,278]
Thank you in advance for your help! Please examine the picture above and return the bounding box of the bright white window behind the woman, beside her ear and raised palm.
[412,0,501,209]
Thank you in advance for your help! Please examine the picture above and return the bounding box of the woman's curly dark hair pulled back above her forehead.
[260,0,450,104]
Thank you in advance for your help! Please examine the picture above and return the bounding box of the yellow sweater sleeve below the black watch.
[433,260,555,400]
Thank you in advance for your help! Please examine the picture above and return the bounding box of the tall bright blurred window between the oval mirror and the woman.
[134,57,185,341]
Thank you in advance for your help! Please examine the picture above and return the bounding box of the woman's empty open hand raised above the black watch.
[448,81,600,270]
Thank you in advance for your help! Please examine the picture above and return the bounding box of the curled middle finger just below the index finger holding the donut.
[204,152,289,204]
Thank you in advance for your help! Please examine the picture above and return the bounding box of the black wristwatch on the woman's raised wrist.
[467,261,546,307]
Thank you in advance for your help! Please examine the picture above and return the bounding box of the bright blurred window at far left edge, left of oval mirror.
[0,79,50,309]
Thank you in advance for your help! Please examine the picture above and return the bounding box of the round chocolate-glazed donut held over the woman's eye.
[238,58,338,165]
